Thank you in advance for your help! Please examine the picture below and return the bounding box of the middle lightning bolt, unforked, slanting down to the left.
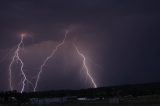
[34,31,68,92]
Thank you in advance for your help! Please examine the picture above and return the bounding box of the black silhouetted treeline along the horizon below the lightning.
[0,83,160,102]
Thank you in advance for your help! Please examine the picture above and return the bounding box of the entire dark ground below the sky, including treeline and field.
[0,83,160,106]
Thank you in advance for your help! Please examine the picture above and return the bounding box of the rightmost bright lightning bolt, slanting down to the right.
[74,45,97,88]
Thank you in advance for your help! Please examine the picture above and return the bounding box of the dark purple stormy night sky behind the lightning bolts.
[0,0,160,91]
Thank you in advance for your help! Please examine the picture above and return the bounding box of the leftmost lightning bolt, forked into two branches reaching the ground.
[9,34,31,93]
